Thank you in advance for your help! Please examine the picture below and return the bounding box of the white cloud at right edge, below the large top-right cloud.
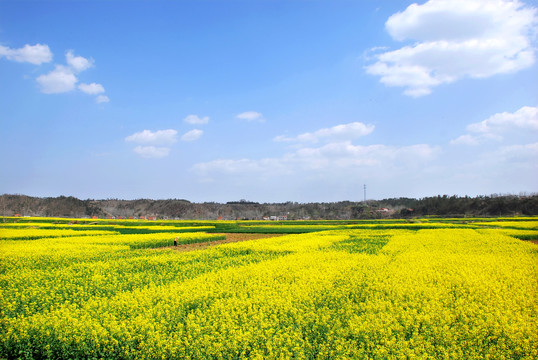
[451,106,538,145]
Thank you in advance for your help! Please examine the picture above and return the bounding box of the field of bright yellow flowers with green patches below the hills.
[0,218,538,360]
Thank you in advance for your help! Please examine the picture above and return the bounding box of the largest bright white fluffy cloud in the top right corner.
[366,0,537,97]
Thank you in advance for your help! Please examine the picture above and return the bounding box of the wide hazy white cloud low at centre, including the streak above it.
[192,122,440,178]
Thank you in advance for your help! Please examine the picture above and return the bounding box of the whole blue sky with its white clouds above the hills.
[0,0,538,202]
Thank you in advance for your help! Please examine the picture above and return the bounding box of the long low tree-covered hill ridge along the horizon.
[0,194,538,220]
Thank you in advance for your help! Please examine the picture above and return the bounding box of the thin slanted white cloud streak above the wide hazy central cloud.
[274,122,375,143]
